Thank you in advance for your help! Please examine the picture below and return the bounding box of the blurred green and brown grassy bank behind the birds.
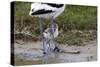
[14,2,97,45]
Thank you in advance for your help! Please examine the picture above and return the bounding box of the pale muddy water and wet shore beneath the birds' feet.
[14,41,97,65]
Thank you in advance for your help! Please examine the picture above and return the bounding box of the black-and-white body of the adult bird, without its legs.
[29,3,65,19]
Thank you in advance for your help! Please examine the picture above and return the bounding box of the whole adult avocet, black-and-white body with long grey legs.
[29,3,65,53]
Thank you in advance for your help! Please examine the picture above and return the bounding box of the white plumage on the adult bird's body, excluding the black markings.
[29,3,65,19]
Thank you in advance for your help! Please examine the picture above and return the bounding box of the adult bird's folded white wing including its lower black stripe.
[31,3,56,15]
